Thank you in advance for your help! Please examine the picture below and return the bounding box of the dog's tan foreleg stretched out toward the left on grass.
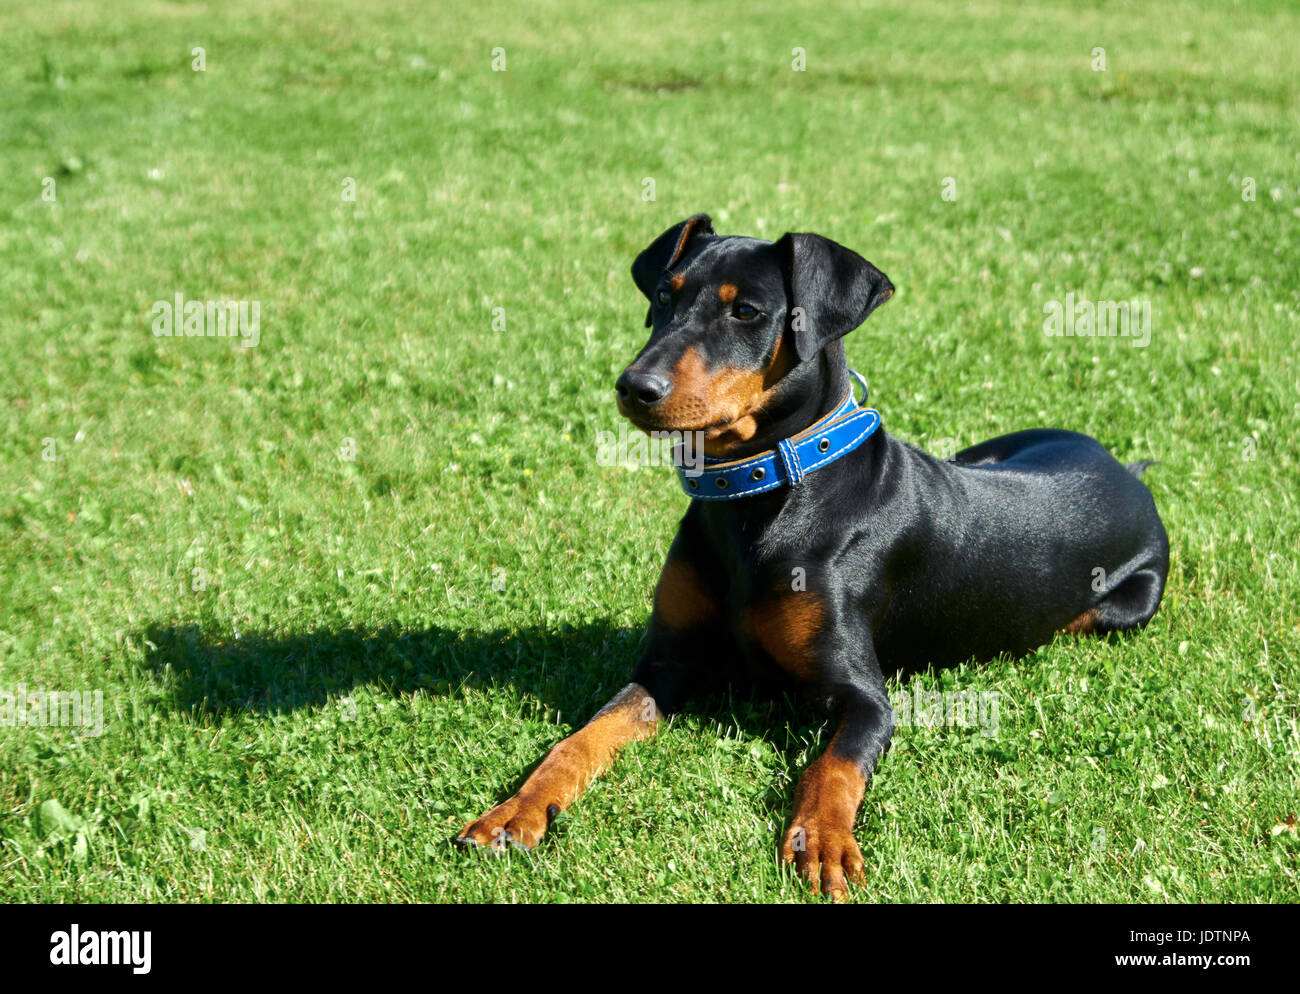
[456,683,663,851]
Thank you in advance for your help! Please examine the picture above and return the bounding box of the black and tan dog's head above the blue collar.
[616,214,893,455]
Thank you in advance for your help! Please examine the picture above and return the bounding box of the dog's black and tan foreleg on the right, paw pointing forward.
[781,675,893,902]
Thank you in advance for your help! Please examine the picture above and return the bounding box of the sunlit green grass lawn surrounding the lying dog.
[0,0,1300,902]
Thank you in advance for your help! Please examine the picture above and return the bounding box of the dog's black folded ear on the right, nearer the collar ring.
[776,233,893,363]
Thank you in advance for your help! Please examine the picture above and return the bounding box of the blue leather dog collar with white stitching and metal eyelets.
[677,369,880,500]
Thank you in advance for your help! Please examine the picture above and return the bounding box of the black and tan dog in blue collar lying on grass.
[458,214,1169,898]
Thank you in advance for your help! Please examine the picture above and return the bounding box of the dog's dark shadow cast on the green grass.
[142,622,824,748]
